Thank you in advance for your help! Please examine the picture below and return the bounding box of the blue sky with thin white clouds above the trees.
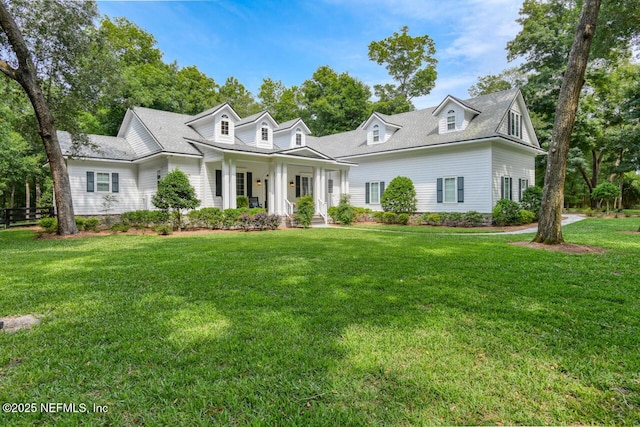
[98,0,522,108]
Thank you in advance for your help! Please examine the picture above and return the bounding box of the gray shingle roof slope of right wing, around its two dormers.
[307,89,532,158]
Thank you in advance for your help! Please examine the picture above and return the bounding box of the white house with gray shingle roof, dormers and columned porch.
[59,89,544,218]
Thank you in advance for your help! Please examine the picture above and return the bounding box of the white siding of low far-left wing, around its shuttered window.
[67,160,141,215]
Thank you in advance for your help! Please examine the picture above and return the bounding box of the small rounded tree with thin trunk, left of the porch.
[151,169,200,229]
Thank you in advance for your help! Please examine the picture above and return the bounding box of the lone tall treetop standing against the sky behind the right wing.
[369,26,438,109]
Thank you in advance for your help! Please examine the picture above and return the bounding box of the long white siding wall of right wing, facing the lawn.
[349,143,492,212]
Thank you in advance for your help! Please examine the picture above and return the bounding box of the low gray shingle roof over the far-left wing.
[58,131,136,161]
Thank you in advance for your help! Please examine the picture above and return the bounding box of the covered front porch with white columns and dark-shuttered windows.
[202,153,350,222]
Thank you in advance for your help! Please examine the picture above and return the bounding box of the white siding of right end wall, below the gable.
[491,143,535,205]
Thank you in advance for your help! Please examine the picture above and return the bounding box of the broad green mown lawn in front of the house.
[0,219,640,426]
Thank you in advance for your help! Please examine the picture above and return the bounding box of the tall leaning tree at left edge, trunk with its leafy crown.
[0,0,97,235]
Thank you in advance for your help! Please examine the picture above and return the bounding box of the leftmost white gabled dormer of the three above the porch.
[186,103,240,144]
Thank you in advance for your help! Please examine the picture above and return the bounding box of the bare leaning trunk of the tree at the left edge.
[0,0,78,235]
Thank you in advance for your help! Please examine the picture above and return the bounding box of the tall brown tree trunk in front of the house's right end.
[533,0,600,245]
